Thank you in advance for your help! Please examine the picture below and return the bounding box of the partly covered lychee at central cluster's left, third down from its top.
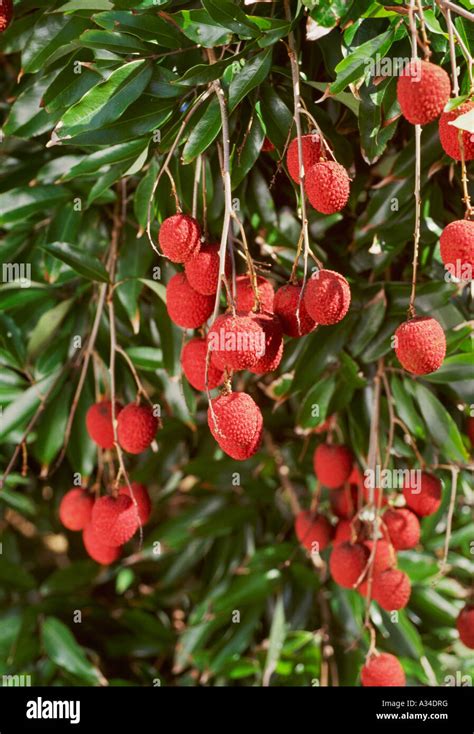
[166,273,214,329]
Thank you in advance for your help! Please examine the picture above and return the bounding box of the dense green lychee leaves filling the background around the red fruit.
[0,0,474,686]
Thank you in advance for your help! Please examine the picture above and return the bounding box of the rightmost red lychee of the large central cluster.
[304,270,351,325]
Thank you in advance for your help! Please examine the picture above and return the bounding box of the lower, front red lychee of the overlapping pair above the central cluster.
[305,161,350,214]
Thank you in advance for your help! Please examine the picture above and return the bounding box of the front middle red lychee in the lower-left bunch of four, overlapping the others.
[91,494,139,547]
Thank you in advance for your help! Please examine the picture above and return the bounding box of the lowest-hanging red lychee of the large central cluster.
[207,392,263,461]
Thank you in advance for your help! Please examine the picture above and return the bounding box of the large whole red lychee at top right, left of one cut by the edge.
[397,59,451,125]
